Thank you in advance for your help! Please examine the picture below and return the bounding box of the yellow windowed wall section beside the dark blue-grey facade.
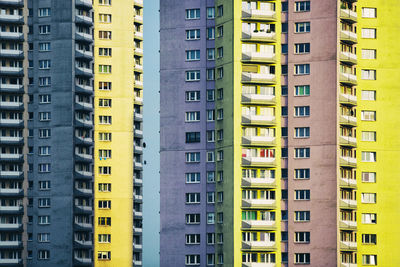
[93,0,135,266]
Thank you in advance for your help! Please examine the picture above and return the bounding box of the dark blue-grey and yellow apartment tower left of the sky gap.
[0,0,143,266]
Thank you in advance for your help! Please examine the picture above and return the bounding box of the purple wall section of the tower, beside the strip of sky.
[160,0,215,267]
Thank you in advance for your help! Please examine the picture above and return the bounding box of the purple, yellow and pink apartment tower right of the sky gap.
[160,0,400,267]
